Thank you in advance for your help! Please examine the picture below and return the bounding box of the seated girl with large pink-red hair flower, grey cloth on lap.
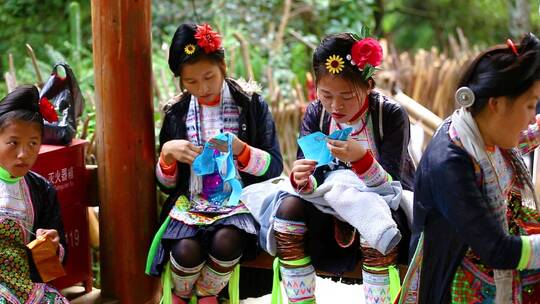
[245,33,413,303]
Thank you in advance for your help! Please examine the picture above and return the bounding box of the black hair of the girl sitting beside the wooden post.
[169,23,225,76]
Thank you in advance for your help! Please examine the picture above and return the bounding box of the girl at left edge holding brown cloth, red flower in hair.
[0,85,68,304]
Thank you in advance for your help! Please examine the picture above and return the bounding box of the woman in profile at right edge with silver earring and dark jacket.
[400,34,540,303]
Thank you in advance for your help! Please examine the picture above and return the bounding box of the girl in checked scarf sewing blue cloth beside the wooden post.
[147,24,283,303]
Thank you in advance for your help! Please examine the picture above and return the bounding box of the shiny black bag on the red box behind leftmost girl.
[39,63,84,145]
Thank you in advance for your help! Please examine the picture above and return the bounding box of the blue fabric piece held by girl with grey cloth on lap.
[298,127,352,167]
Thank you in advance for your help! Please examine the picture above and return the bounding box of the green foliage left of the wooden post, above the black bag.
[0,0,95,135]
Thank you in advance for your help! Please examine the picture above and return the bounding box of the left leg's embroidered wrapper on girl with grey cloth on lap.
[272,218,316,304]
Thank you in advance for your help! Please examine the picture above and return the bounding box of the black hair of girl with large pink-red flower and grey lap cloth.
[313,33,375,89]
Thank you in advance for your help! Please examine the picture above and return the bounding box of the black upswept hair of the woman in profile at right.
[458,33,540,115]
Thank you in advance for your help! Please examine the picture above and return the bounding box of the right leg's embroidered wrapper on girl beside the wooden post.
[192,255,240,297]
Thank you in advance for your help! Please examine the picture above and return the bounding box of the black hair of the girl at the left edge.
[0,85,43,132]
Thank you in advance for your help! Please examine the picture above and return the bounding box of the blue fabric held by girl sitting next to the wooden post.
[192,132,242,206]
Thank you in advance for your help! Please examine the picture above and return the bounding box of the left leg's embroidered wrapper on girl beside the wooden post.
[170,254,205,300]
